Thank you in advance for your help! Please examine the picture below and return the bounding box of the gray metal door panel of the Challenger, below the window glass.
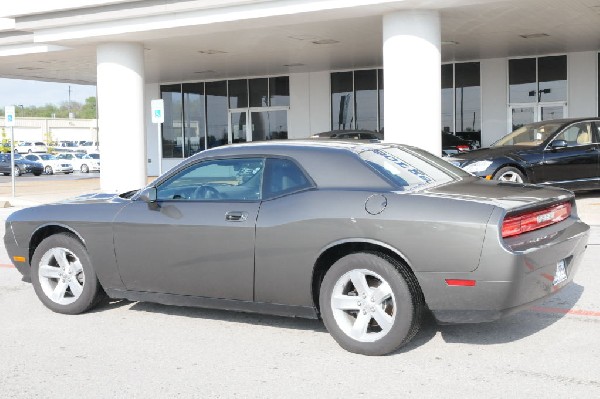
[114,201,260,301]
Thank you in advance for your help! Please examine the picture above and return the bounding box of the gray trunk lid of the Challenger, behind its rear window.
[426,177,574,211]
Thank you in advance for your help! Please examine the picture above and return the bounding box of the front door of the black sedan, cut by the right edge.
[538,122,600,189]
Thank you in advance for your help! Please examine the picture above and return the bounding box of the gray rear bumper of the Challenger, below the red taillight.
[417,219,589,323]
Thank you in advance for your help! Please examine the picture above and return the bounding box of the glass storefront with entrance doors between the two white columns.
[160,76,290,158]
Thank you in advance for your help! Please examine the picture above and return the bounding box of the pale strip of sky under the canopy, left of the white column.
[0,79,96,108]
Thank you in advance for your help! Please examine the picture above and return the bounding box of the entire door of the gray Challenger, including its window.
[114,158,265,301]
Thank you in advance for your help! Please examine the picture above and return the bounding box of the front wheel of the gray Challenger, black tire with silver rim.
[31,233,105,314]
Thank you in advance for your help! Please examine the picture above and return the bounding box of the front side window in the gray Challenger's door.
[157,158,265,201]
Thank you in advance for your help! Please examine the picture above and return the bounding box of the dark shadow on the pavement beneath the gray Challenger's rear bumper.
[438,283,584,345]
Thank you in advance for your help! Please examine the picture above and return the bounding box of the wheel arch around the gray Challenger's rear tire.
[311,239,423,314]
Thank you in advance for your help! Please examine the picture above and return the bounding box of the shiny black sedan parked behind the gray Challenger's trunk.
[446,118,600,190]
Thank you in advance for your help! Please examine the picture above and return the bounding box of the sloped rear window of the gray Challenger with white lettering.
[360,147,469,190]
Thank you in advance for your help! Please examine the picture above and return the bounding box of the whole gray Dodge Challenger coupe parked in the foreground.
[4,140,589,355]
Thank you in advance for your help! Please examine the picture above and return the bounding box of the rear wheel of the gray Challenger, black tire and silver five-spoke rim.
[319,252,425,356]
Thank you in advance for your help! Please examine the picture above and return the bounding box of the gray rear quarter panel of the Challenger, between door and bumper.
[255,190,494,306]
